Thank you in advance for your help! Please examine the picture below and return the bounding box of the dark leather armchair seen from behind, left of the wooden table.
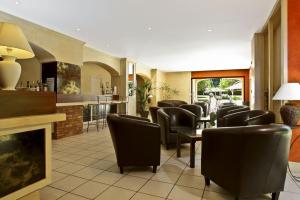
[107,114,160,174]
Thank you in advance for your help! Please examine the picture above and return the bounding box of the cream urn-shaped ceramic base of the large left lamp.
[0,56,21,90]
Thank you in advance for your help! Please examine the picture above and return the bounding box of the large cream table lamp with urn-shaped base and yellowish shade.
[0,22,34,90]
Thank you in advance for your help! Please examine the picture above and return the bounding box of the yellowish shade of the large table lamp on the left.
[0,22,34,59]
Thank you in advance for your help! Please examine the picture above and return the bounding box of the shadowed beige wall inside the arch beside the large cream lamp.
[17,58,42,86]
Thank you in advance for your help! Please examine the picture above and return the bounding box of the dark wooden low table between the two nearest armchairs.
[176,127,202,168]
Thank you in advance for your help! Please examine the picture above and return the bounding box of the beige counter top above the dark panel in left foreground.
[0,113,66,130]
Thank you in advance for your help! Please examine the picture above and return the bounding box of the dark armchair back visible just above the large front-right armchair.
[222,110,275,127]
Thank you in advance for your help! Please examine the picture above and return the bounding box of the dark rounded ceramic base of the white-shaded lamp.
[280,104,300,126]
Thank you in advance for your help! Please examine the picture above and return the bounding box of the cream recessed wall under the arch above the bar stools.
[81,63,111,95]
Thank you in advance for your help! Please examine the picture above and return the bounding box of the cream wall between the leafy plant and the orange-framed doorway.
[165,72,192,103]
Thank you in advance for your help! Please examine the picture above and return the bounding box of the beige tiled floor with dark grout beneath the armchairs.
[41,129,300,200]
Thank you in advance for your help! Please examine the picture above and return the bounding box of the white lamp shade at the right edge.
[273,83,300,100]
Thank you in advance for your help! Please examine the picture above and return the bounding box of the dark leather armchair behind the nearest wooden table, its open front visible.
[157,107,197,149]
